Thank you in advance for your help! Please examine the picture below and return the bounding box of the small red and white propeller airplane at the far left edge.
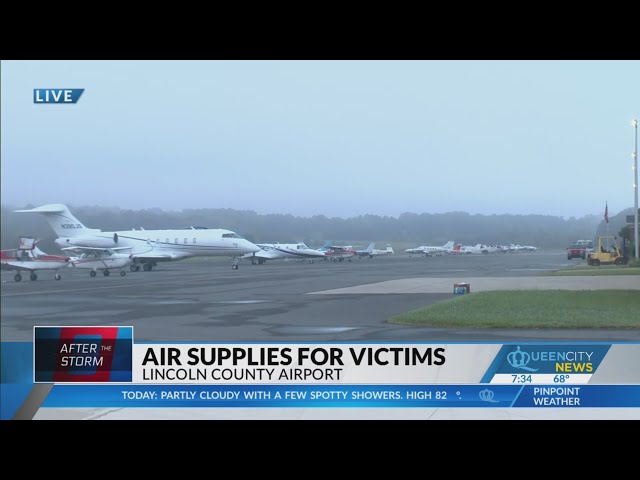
[0,237,72,282]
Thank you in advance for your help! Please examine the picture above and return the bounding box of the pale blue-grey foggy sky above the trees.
[0,60,640,217]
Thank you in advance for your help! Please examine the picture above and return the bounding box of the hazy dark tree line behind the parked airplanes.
[1,205,633,255]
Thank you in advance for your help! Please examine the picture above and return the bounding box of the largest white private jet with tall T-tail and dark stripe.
[16,204,260,272]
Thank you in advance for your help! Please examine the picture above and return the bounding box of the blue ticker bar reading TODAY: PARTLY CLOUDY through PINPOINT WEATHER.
[42,385,640,408]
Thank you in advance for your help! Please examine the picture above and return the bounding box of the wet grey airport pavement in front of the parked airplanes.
[1,251,640,342]
